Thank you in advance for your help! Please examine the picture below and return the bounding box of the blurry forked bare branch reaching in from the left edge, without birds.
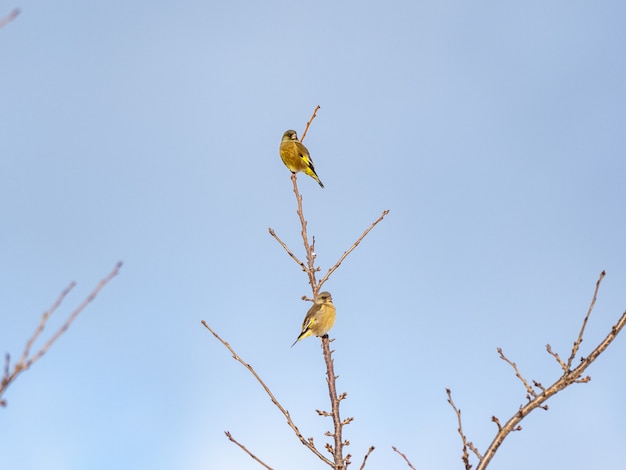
[0,262,122,406]
